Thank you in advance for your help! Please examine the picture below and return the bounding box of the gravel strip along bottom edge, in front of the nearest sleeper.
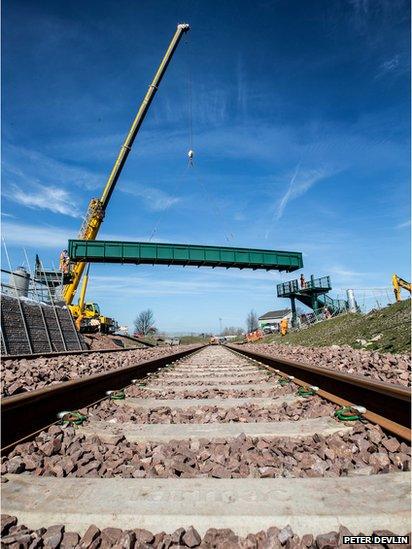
[1,515,402,549]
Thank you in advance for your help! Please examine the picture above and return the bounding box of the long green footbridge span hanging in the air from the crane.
[68,240,303,272]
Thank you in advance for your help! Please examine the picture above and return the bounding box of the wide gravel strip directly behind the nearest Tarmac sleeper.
[1,423,410,478]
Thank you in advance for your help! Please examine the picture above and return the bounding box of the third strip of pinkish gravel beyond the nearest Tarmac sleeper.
[125,383,297,399]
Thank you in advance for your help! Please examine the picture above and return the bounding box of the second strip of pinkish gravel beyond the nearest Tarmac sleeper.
[88,397,337,424]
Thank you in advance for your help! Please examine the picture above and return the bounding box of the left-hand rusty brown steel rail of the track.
[1,345,204,452]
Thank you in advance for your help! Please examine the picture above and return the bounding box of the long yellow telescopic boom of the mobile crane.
[63,23,190,305]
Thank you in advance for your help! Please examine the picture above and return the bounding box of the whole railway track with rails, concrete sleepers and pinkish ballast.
[2,346,410,549]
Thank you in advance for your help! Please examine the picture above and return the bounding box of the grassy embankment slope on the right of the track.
[259,299,411,353]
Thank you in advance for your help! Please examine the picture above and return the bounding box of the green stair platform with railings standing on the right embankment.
[277,275,349,326]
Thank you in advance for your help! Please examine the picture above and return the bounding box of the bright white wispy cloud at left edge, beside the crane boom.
[3,184,81,217]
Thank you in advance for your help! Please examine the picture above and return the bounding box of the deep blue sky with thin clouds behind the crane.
[2,0,410,332]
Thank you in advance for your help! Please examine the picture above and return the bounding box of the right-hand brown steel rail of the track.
[226,344,411,441]
